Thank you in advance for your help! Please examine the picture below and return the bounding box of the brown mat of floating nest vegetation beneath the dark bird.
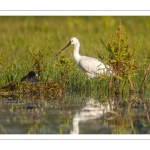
[0,81,63,99]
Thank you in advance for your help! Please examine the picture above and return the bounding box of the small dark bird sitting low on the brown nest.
[20,71,38,82]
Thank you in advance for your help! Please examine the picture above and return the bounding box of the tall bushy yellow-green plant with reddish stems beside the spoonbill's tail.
[99,22,137,95]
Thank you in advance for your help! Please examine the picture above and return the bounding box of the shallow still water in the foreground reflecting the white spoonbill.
[0,95,150,134]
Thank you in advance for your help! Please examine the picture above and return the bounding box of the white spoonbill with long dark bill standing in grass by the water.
[56,37,111,79]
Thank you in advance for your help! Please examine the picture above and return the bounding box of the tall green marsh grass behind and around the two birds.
[0,16,150,93]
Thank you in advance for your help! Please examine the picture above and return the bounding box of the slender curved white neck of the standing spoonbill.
[73,41,80,63]
